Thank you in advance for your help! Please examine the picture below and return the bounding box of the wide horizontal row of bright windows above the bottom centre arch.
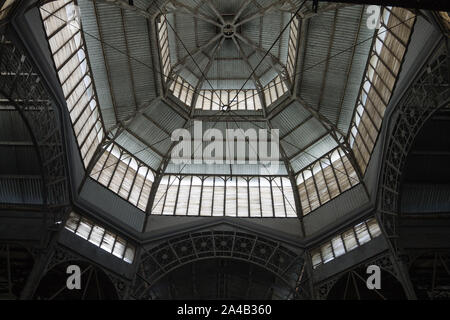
[150,175,297,218]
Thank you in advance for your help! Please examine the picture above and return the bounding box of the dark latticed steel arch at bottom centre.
[130,231,309,299]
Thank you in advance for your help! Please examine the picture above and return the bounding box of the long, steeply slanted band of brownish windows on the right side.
[347,7,415,175]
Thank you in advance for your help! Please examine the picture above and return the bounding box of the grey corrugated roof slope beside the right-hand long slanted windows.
[299,5,373,131]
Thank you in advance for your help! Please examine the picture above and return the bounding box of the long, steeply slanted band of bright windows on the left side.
[40,0,105,169]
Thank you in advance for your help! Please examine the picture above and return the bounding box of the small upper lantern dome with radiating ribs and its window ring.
[158,0,298,110]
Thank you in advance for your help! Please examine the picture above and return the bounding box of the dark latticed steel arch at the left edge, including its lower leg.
[0,35,70,299]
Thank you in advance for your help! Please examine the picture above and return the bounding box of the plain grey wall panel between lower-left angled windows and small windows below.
[80,179,145,231]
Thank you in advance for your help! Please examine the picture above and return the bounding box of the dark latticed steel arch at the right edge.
[378,39,450,248]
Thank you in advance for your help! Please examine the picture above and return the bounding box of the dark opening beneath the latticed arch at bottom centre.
[150,259,293,300]
